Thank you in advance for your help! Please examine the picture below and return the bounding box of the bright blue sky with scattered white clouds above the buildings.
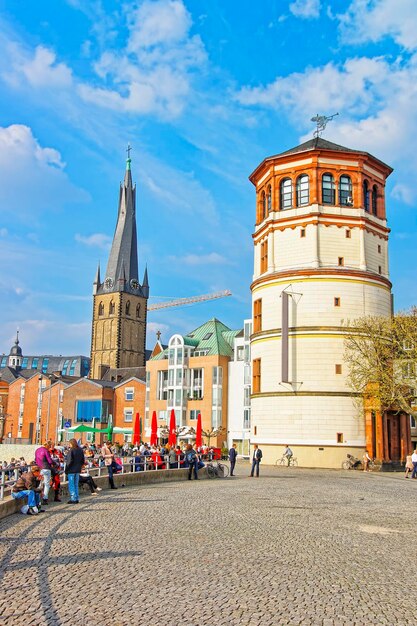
[0,0,417,354]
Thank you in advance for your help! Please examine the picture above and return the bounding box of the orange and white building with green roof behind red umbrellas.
[145,318,243,446]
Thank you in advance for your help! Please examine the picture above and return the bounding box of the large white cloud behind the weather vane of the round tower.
[237,54,417,204]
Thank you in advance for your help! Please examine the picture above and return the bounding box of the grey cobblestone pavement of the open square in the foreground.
[0,464,417,626]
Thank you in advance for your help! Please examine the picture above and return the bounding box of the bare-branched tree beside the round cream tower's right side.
[344,308,417,414]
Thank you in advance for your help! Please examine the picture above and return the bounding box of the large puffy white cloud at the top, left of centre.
[78,0,206,118]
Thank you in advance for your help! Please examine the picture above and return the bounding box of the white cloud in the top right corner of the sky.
[337,0,417,50]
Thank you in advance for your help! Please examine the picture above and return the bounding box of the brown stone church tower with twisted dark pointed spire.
[90,155,149,379]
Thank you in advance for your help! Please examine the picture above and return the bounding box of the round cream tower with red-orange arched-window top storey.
[250,138,392,467]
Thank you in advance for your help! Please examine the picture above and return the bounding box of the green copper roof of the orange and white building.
[152,317,242,361]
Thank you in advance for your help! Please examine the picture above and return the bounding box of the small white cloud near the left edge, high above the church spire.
[3,44,72,88]
